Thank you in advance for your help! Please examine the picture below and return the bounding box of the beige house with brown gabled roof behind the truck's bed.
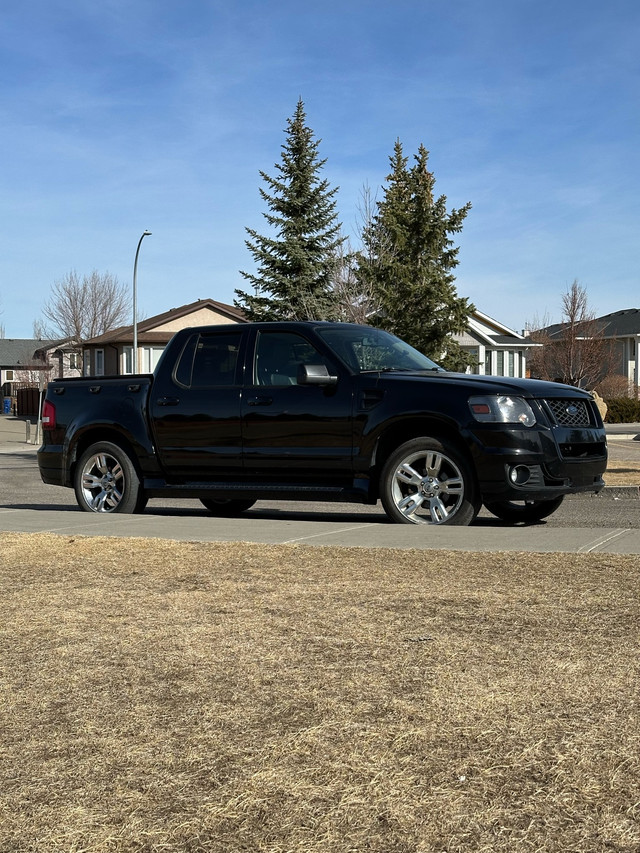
[83,299,247,376]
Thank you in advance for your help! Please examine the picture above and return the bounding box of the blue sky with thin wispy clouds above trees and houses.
[0,0,640,338]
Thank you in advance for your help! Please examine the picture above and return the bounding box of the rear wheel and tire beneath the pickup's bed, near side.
[74,441,147,513]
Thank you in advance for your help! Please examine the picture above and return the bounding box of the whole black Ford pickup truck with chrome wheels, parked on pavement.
[38,322,607,525]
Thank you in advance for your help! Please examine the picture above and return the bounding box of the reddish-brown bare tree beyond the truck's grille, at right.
[529,281,614,388]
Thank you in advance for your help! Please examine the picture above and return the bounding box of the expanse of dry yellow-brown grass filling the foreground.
[0,534,640,853]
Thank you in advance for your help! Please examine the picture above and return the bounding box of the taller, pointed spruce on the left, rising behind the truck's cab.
[235,99,344,320]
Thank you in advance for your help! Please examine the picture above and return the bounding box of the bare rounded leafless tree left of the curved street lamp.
[42,270,131,344]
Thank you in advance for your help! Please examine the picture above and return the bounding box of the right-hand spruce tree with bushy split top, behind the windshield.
[358,140,474,369]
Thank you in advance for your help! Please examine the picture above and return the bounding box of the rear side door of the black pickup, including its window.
[149,327,243,482]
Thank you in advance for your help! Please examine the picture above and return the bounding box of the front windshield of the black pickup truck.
[318,326,442,372]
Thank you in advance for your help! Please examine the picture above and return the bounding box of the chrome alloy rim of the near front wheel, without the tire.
[391,450,465,524]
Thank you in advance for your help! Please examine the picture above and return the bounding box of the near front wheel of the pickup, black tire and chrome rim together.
[380,436,480,525]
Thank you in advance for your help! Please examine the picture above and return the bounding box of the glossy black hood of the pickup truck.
[380,371,590,399]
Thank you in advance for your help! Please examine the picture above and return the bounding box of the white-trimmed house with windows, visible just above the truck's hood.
[453,310,538,377]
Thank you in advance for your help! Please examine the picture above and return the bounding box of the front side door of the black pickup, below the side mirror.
[242,329,352,486]
